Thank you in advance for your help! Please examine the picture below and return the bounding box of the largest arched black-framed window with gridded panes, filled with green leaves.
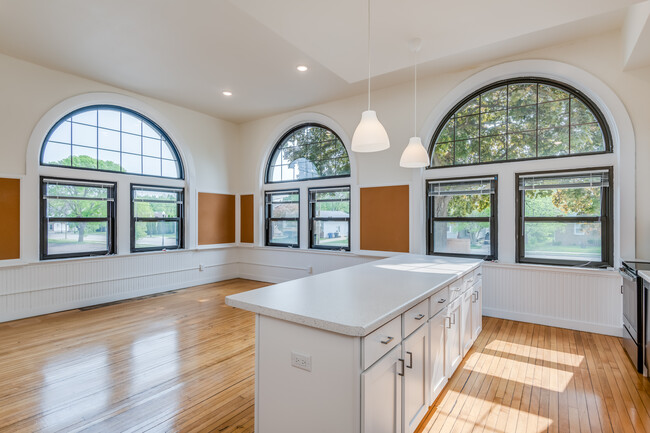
[429,78,612,168]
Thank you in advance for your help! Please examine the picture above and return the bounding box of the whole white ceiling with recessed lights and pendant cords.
[0,0,650,122]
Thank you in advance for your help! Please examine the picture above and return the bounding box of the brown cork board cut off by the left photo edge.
[0,179,20,260]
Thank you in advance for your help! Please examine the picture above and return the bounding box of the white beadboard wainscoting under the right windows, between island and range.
[483,263,623,337]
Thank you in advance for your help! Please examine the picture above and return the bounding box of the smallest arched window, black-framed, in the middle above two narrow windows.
[266,123,350,183]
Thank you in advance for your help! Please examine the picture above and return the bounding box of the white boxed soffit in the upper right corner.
[623,1,650,70]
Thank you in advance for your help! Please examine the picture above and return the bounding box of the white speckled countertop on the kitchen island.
[226,254,482,336]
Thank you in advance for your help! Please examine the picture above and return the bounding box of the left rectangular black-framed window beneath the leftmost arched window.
[41,178,115,260]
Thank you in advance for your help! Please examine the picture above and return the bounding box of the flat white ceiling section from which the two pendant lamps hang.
[231,0,641,83]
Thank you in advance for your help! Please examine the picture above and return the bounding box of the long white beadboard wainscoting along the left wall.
[0,248,238,322]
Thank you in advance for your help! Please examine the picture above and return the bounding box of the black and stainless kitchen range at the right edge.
[619,260,650,376]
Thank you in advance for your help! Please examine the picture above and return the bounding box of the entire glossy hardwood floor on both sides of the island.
[0,280,650,433]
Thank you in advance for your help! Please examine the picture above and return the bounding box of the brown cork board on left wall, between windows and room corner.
[198,192,235,245]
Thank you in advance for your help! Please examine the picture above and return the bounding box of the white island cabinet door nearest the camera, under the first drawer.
[361,344,405,433]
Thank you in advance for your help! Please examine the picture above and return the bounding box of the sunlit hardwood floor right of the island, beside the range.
[418,317,650,433]
